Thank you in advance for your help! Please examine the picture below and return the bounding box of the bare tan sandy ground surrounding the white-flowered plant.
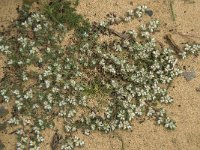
[0,0,200,150]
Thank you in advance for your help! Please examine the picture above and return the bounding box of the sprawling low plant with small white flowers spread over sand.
[0,3,200,150]
